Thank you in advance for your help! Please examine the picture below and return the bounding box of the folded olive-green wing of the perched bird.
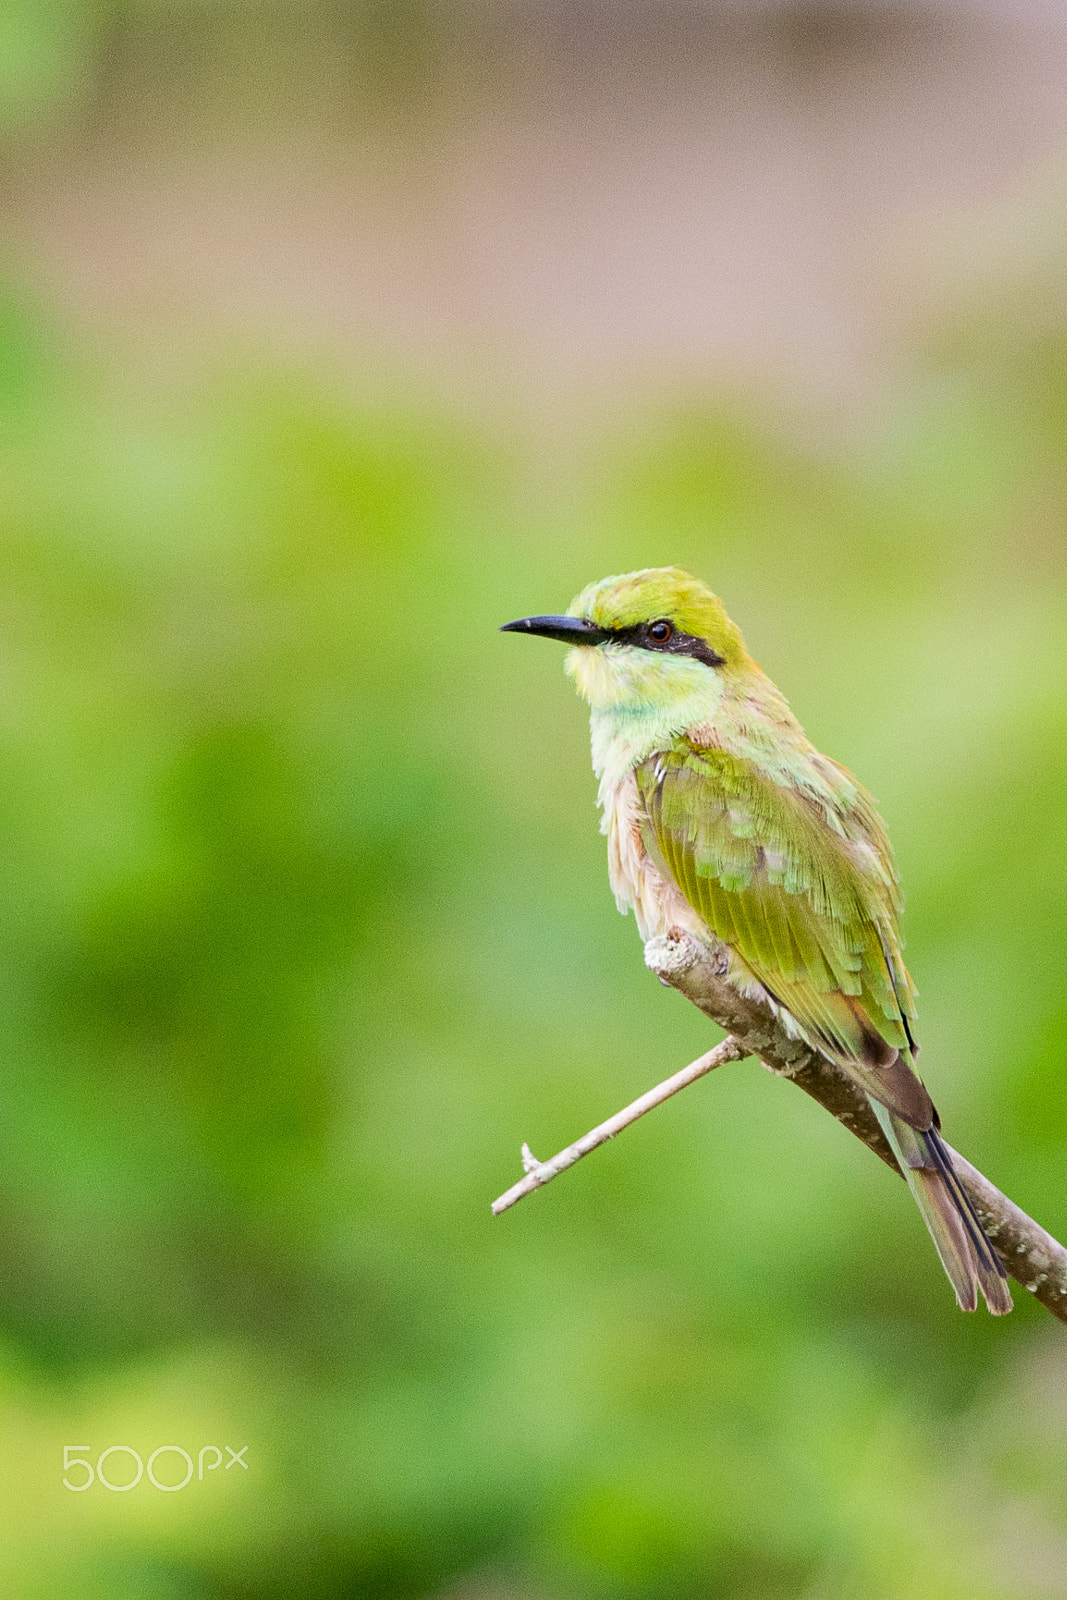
[637,741,933,1126]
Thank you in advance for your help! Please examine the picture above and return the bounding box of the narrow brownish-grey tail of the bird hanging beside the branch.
[870,1099,1011,1317]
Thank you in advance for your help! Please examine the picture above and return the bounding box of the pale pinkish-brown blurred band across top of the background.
[3,0,1067,411]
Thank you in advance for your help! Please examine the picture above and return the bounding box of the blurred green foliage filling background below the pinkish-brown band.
[0,268,1067,1600]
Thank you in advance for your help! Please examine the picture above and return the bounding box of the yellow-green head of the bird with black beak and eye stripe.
[502,566,750,710]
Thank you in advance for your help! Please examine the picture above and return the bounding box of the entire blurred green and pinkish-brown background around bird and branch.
[0,0,1067,1600]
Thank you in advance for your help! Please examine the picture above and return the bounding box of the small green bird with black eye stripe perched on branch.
[501,566,1011,1315]
